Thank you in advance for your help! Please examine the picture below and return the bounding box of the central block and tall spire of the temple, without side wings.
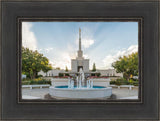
[71,28,89,73]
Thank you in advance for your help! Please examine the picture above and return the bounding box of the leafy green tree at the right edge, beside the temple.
[112,52,138,80]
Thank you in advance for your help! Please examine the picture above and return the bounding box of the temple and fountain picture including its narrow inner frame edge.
[18,18,143,103]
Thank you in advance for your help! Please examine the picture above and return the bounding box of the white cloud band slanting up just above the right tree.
[103,45,138,68]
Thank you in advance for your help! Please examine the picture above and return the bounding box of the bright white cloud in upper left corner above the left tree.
[22,22,37,50]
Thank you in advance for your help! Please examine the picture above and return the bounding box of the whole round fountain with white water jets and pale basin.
[49,69,112,99]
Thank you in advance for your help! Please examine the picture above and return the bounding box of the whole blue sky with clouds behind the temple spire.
[22,22,138,69]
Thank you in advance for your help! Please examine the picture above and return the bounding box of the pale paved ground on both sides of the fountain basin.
[22,88,138,99]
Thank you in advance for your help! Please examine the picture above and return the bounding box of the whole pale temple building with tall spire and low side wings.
[38,28,123,77]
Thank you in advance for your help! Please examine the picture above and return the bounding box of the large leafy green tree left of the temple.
[22,47,52,79]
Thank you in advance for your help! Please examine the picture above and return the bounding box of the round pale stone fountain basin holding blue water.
[49,86,112,99]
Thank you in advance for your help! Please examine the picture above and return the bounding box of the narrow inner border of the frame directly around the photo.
[16,16,144,104]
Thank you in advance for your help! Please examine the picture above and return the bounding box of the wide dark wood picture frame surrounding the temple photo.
[1,1,159,120]
